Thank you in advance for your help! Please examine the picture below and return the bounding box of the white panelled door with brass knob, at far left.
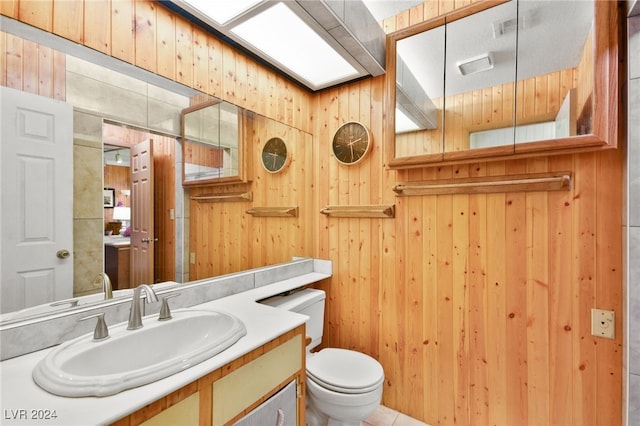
[0,87,73,313]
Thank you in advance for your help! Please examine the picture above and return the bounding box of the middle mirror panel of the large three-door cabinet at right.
[444,1,518,152]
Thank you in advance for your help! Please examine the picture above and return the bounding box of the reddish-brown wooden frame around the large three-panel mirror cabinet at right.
[384,0,621,169]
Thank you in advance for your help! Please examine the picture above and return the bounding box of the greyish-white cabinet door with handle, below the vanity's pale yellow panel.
[234,380,298,426]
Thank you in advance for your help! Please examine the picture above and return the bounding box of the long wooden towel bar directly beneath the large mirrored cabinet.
[393,172,571,195]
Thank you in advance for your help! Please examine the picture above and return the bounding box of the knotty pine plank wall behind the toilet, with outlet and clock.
[315,1,622,425]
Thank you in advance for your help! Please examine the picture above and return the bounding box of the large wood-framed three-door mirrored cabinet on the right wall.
[387,0,618,168]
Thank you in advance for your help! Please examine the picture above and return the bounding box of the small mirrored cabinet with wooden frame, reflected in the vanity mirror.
[181,99,247,186]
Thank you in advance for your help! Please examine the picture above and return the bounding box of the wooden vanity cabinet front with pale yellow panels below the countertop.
[114,325,305,426]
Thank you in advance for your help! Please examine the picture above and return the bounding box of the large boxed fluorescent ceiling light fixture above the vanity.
[168,0,386,91]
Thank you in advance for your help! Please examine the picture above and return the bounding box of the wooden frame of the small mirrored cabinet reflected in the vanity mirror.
[180,97,251,187]
